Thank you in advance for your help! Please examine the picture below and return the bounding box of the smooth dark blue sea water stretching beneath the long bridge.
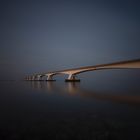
[0,70,140,140]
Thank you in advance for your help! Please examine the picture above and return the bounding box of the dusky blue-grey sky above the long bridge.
[0,0,140,80]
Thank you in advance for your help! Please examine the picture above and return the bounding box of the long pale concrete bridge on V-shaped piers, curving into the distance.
[25,59,140,82]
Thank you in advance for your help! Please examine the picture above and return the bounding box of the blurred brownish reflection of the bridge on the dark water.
[29,81,140,105]
